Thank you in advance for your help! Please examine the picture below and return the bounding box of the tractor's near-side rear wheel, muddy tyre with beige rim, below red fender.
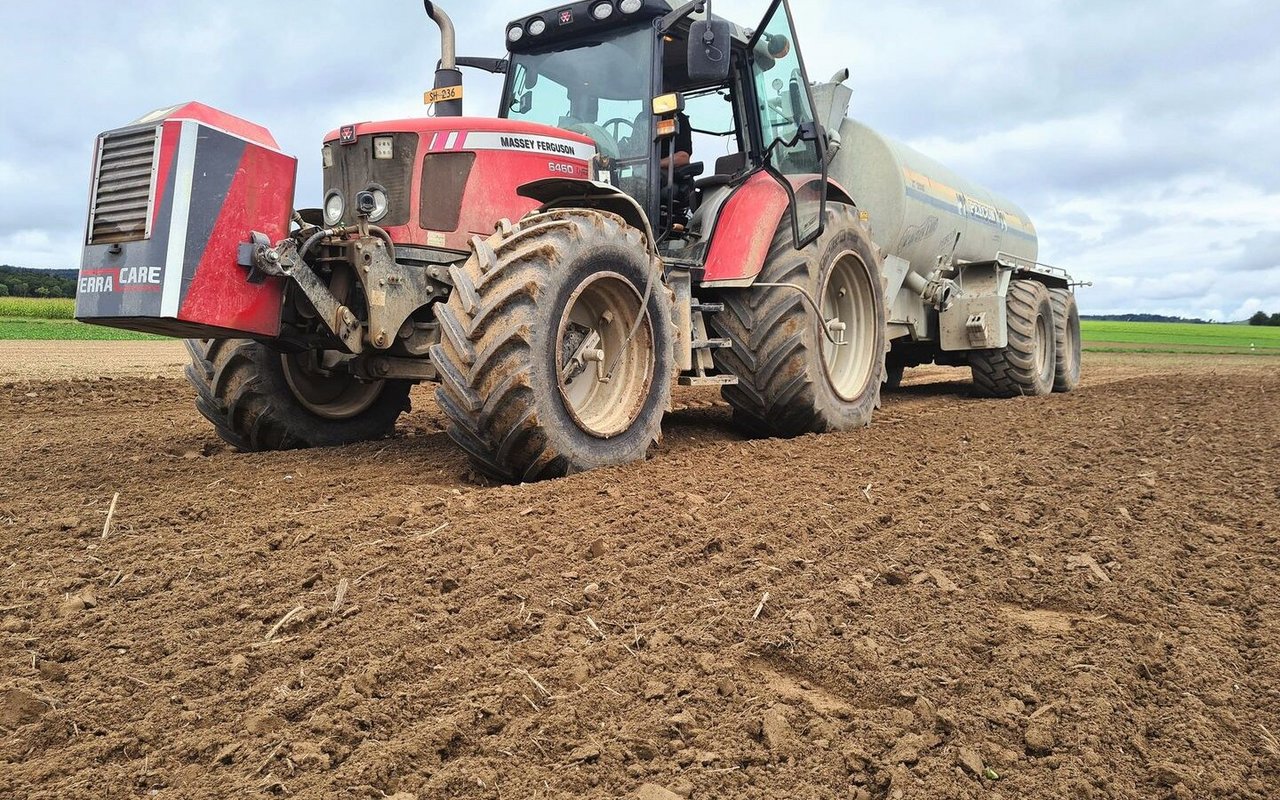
[710,204,888,436]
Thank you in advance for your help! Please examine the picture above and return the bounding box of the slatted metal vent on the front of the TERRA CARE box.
[88,125,160,244]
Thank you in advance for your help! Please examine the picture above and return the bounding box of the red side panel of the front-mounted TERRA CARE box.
[178,145,296,337]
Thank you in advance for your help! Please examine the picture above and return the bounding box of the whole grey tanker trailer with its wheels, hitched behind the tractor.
[814,72,1080,397]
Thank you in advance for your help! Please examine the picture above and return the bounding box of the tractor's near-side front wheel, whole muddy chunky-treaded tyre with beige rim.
[431,209,675,483]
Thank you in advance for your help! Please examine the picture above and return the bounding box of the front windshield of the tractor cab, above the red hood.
[502,26,655,209]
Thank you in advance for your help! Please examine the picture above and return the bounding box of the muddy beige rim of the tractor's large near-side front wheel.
[556,271,654,439]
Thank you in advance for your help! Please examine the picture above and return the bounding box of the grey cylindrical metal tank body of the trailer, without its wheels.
[814,79,1038,276]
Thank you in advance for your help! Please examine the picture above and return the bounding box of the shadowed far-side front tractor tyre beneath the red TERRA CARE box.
[186,339,412,452]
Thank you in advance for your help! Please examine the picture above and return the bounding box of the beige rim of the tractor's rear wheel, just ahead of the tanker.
[818,251,876,401]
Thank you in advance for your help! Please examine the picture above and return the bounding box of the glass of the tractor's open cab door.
[751,0,826,246]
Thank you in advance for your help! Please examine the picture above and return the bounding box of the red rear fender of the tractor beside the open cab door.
[703,170,854,287]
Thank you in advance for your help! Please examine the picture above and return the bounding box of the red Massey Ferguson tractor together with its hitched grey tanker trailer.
[77,0,1080,481]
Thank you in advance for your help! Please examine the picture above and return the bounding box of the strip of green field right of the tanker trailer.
[1080,320,1280,356]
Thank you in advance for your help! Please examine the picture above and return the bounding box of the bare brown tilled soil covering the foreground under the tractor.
[0,346,1280,800]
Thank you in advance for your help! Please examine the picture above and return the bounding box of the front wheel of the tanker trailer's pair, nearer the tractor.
[969,280,1057,397]
